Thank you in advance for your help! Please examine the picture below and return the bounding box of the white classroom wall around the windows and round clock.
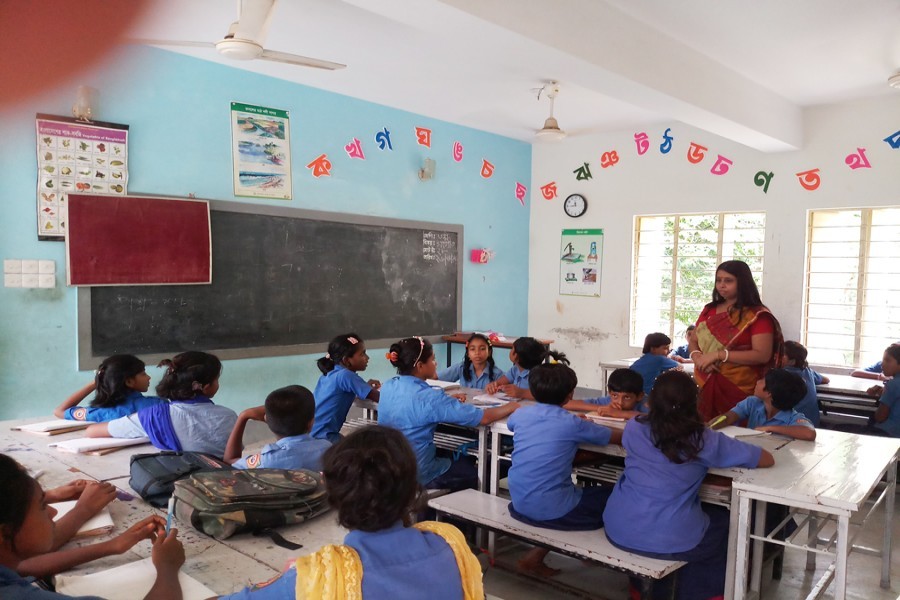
[528,93,900,385]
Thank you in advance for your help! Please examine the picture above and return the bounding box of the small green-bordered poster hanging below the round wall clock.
[559,229,603,298]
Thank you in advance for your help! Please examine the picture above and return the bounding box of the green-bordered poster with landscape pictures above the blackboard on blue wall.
[231,102,292,200]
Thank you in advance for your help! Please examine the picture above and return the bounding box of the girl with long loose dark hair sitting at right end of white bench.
[603,371,775,600]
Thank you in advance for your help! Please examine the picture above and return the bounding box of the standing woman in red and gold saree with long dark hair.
[689,260,784,420]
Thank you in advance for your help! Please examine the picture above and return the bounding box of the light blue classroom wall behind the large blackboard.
[0,47,531,419]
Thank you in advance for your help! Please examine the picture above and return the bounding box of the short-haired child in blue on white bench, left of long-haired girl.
[508,363,622,577]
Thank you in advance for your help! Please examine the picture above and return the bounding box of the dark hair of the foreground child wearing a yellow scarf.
[322,425,419,531]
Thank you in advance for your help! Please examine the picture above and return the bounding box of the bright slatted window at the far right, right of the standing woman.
[803,207,900,366]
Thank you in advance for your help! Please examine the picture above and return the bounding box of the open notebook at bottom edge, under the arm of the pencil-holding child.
[56,558,218,600]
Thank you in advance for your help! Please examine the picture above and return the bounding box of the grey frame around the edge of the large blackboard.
[76,200,464,370]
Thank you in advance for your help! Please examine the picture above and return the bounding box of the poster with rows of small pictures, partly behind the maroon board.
[36,113,128,241]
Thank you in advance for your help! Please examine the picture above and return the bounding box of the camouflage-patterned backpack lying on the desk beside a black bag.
[175,469,328,549]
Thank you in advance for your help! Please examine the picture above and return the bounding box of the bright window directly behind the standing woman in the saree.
[631,212,766,346]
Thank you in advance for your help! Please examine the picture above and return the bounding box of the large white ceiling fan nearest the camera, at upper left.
[131,0,347,71]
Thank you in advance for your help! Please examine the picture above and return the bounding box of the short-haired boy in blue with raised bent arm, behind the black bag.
[223,385,331,471]
